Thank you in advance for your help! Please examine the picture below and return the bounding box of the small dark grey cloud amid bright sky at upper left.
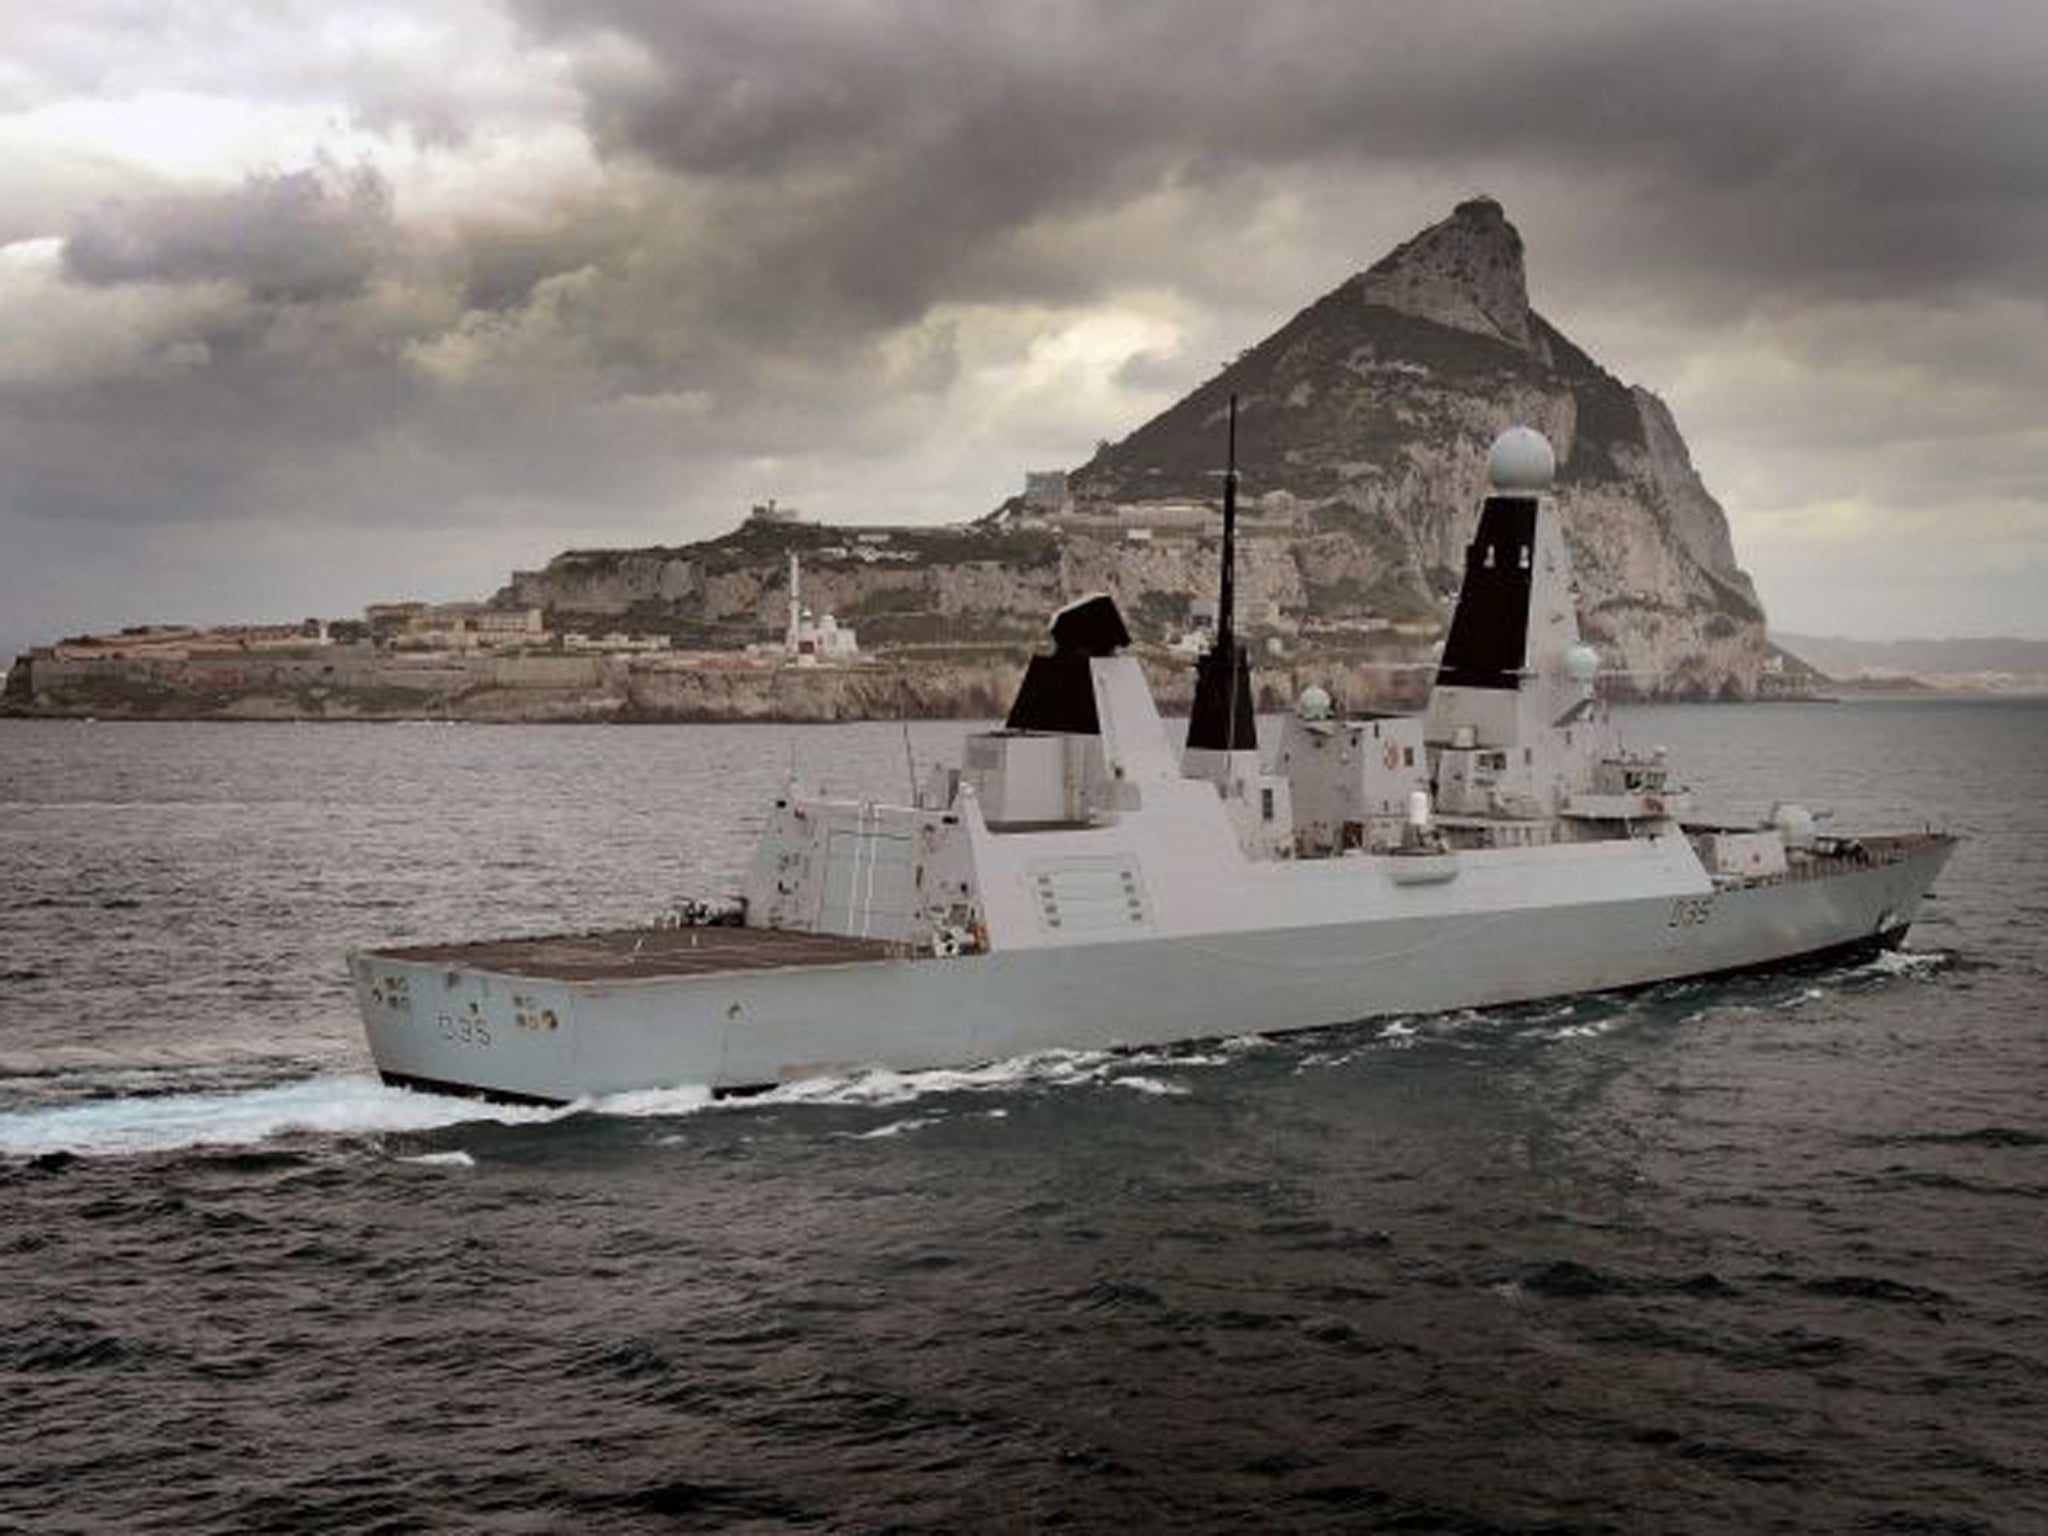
[63,168,391,303]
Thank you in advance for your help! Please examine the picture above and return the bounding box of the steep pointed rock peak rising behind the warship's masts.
[1071,199,1767,694]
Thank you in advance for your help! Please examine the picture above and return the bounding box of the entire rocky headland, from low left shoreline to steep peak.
[6,199,1769,719]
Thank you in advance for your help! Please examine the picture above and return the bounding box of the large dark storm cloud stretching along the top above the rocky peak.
[507,0,2048,319]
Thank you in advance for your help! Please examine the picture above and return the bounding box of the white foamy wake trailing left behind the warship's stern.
[0,1077,563,1157]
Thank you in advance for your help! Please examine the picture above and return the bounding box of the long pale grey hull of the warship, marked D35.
[352,838,1952,1102]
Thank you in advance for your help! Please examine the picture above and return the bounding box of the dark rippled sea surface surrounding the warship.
[0,700,2048,1532]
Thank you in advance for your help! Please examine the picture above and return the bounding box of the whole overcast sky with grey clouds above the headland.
[0,0,2048,645]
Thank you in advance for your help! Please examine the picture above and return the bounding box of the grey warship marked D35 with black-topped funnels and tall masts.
[350,417,1954,1104]
